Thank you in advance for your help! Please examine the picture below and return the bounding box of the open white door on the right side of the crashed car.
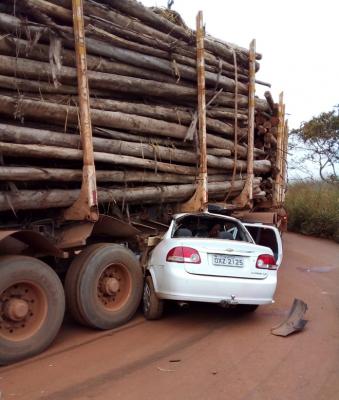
[243,222,283,267]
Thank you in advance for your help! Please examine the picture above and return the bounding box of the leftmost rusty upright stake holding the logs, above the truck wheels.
[64,0,99,222]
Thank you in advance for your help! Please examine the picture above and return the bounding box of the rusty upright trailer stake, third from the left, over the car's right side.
[233,39,256,207]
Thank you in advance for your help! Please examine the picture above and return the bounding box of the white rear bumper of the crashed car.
[150,265,277,304]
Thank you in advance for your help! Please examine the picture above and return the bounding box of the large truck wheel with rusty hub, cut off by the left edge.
[0,256,65,365]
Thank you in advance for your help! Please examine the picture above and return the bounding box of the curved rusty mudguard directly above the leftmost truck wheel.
[0,230,67,258]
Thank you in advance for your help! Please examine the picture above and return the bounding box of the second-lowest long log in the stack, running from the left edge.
[0,166,197,184]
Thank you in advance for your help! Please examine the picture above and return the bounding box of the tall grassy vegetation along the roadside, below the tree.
[286,181,339,243]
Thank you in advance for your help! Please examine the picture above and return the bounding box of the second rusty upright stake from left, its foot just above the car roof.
[180,11,208,212]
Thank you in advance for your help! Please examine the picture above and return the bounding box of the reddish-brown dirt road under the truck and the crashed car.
[0,234,339,400]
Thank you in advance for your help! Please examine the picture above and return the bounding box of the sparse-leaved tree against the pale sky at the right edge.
[291,111,339,182]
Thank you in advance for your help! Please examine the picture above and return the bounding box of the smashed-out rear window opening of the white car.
[172,215,252,242]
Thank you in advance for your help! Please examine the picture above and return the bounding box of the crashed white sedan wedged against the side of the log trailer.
[143,213,282,319]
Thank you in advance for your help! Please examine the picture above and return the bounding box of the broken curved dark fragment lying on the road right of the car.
[271,299,308,336]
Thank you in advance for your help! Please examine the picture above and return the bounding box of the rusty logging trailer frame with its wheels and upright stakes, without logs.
[0,0,283,365]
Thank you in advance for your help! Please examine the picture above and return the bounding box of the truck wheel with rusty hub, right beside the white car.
[65,243,143,329]
